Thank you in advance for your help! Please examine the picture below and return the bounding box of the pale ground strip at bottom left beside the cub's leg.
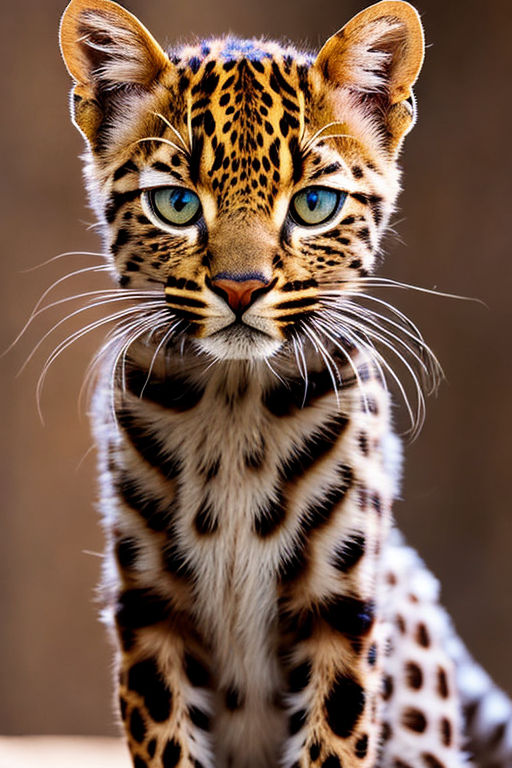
[0,736,130,768]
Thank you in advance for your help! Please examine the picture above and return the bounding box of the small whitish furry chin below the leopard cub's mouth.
[196,324,283,360]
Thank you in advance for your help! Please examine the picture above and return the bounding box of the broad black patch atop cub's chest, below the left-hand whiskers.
[126,366,204,413]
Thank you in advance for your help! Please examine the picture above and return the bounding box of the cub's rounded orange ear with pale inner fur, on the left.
[60,0,169,147]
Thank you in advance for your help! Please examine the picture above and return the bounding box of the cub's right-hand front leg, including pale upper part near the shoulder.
[281,468,388,768]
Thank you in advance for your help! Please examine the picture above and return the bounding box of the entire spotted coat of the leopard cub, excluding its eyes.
[61,0,512,768]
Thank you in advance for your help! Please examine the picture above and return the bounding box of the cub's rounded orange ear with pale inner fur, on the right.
[315,0,425,148]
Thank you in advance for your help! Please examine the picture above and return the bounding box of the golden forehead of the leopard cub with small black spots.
[160,38,318,209]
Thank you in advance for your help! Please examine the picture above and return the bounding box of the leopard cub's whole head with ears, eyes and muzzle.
[61,0,422,359]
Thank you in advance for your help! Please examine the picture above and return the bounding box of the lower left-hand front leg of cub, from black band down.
[116,589,213,768]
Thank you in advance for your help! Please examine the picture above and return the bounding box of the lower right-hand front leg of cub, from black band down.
[284,584,388,768]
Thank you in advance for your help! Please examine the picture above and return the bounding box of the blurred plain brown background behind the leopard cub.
[0,0,512,734]
